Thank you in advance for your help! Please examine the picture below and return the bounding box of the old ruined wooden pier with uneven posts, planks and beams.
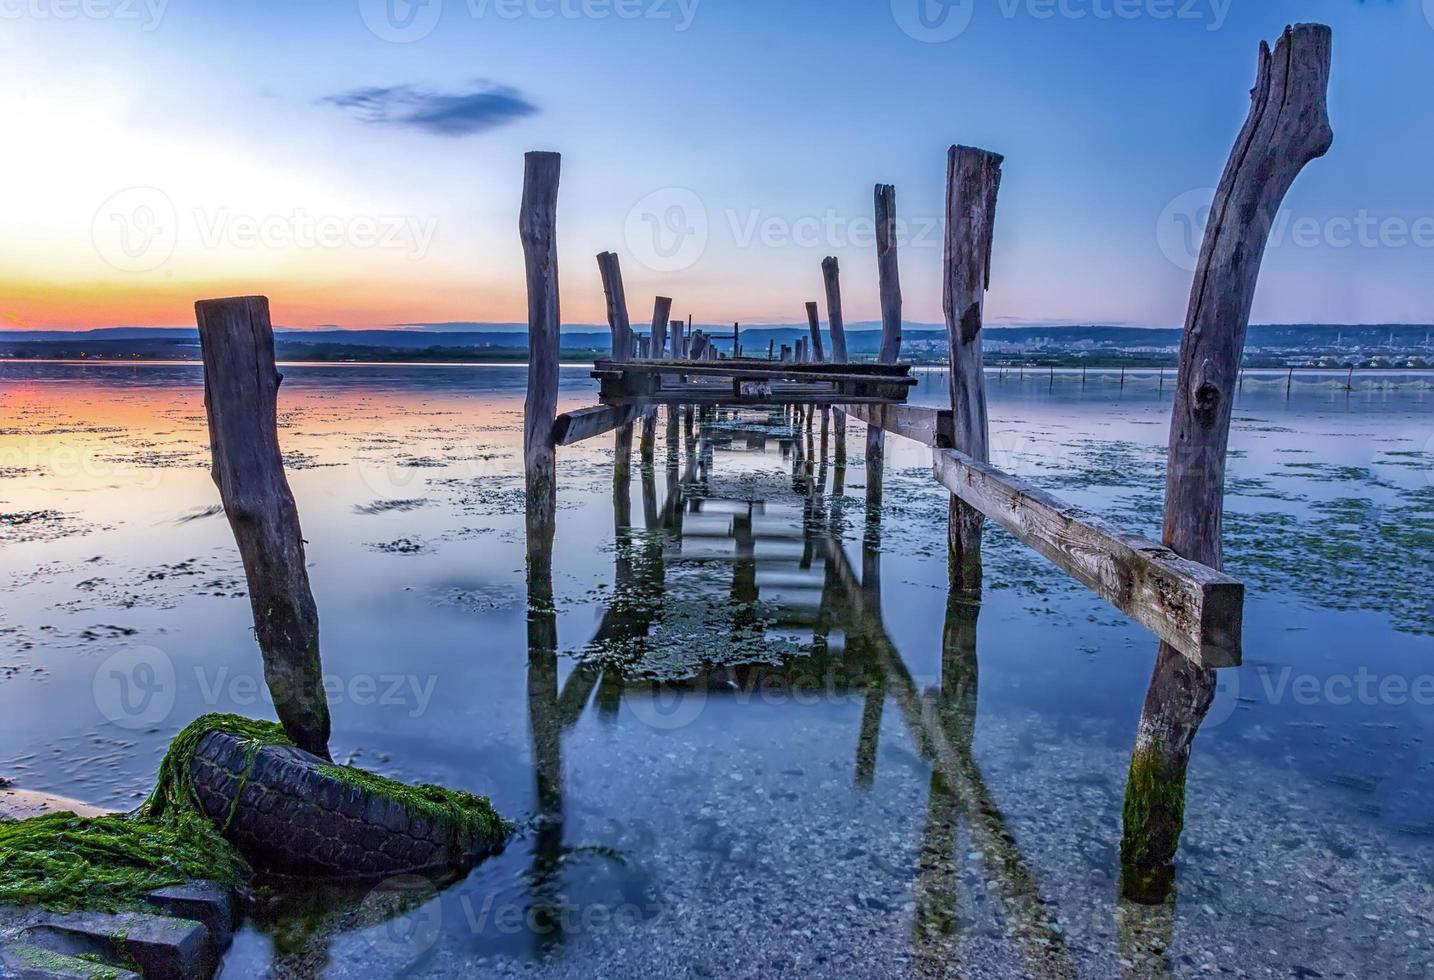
[519,24,1331,903]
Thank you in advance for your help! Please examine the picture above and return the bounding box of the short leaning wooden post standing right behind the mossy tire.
[194,296,328,759]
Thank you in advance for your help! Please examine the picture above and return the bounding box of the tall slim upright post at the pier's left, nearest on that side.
[518,152,562,559]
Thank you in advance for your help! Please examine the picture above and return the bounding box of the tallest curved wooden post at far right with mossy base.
[1120,24,1334,903]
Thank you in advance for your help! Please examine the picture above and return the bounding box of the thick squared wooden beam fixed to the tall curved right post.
[934,449,1245,667]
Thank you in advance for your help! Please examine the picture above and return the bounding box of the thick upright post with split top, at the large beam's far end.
[942,146,1004,593]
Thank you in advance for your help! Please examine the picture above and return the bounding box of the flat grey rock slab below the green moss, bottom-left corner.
[19,913,210,980]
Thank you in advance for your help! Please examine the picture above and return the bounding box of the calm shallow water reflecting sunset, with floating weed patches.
[0,363,1434,977]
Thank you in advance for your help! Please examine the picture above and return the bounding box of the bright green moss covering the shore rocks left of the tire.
[0,715,285,910]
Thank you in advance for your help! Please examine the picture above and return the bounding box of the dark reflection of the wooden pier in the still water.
[531,413,1076,977]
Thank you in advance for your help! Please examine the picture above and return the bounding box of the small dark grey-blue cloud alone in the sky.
[320,82,538,136]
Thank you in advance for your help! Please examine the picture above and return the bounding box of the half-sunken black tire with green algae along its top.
[189,730,506,878]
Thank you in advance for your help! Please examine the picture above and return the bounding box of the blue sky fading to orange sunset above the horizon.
[0,0,1434,327]
